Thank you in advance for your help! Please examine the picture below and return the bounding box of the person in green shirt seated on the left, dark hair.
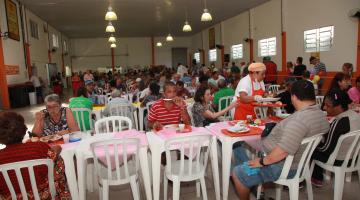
[69,87,93,131]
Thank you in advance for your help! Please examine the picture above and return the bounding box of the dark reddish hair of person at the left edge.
[0,112,27,145]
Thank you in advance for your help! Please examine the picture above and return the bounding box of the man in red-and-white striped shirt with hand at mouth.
[148,82,190,130]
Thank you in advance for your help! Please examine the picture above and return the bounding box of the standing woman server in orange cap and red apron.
[233,63,266,120]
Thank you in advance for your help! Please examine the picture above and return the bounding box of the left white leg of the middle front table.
[151,147,161,200]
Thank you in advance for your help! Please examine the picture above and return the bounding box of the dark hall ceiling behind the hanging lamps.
[19,0,268,38]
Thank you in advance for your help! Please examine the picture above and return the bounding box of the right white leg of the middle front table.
[210,136,220,200]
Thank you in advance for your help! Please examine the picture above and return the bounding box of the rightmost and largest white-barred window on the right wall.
[304,26,334,52]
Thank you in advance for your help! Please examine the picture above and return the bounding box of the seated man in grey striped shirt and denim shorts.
[232,80,329,200]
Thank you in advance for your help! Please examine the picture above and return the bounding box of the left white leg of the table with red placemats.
[222,137,232,200]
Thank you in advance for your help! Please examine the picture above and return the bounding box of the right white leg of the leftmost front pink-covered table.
[139,147,152,200]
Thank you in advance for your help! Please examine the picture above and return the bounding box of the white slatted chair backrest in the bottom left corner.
[0,159,56,200]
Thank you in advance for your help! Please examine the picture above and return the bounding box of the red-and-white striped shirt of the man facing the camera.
[148,99,181,125]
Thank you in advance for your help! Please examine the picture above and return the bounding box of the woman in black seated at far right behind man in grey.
[311,90,360,187]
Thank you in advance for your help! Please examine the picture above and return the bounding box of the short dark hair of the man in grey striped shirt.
[291,80,316,101]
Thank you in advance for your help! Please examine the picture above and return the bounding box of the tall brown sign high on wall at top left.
[5,0,20,41]
